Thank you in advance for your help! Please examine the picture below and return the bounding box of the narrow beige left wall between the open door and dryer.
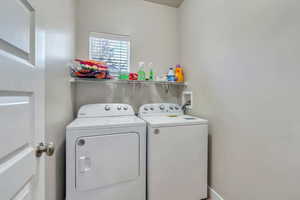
[43,0,75,200]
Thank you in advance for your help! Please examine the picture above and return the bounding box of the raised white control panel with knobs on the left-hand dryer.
[78,104,134,118]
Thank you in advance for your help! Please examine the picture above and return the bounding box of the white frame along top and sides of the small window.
[88,32,132,73]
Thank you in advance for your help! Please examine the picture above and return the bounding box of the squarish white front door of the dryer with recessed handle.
[76,133,140,191]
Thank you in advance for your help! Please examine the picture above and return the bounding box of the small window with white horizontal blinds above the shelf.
[89,33,130,75]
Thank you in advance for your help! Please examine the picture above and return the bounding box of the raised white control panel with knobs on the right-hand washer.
[139,103,183,117]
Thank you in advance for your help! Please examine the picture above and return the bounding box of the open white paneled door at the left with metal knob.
[0,0,45,200]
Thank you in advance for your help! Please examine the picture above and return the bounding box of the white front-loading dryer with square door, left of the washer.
[66,104,146,200]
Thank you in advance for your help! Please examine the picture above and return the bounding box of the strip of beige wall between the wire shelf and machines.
[74,82,185,112]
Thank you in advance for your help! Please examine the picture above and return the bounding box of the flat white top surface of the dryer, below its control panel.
[67,116,146,130]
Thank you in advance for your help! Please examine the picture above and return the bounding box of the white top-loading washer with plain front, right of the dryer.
[139,103,208,200]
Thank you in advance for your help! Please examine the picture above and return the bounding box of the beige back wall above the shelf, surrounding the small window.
[76,0,179,73]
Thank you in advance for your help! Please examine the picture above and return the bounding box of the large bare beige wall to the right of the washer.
[180,0,300,200]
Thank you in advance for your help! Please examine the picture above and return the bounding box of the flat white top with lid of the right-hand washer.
[143,115,208,127]
